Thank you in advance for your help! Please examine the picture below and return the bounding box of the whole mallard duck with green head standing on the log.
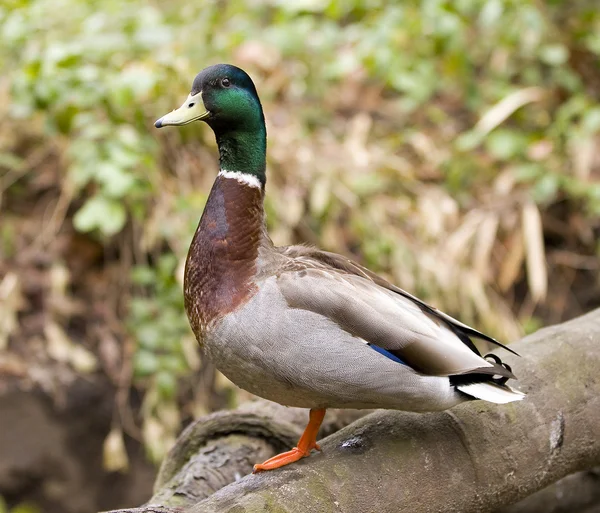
[155,64,524,472]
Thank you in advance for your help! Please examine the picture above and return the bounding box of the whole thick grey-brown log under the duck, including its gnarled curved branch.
[105,310,600,513]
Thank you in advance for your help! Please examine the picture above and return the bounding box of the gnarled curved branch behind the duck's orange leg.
[104,399,372,513]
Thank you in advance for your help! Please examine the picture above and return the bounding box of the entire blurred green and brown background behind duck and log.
[0,0,600,513]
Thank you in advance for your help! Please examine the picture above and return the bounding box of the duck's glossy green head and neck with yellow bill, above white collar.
[154,64,267,182]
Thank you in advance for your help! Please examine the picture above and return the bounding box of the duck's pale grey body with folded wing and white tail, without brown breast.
[204,238,522,411]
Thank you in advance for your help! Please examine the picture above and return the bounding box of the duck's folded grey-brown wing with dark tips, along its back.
[278,246,514,377]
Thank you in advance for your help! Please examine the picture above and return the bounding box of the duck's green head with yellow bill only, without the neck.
[154,64,264,132]
